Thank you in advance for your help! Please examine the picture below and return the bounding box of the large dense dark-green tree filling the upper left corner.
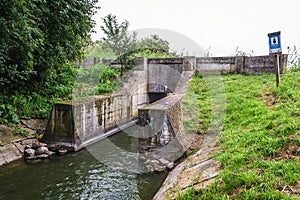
[0,0,98,94]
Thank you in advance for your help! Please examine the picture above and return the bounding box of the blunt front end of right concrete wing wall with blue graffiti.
[139,95,185,161]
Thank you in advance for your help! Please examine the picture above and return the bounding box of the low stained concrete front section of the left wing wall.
[42,94,131,150]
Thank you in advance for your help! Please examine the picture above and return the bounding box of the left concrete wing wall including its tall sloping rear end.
[42,59,148,151]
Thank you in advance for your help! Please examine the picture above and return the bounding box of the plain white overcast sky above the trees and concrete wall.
[93,0,300,56]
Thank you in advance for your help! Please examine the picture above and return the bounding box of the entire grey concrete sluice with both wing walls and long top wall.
[42,55,287,152]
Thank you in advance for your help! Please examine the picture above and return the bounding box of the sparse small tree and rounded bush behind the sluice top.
[99,14,175,76]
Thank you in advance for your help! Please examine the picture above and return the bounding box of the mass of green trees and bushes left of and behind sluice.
[0,3,176,124]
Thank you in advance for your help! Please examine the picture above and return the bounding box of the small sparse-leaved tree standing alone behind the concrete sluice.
[100,14,137,77]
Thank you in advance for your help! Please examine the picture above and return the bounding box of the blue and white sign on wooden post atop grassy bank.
[268,31,282,87]
